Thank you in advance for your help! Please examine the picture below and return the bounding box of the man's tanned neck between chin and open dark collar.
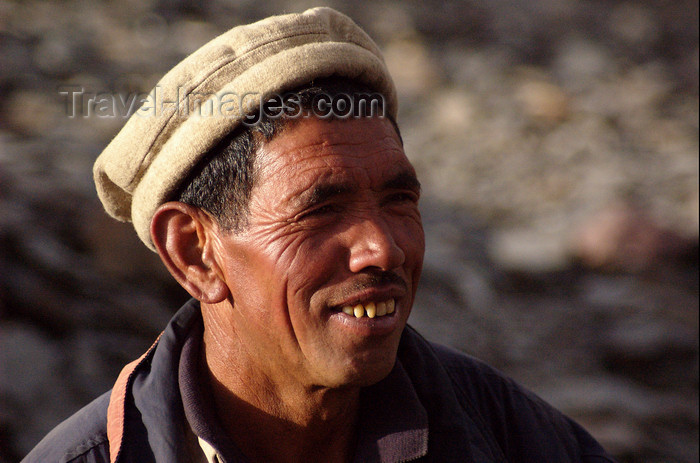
[201,302,360,463]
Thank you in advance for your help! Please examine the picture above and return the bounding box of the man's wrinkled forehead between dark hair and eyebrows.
[256,117,415,196]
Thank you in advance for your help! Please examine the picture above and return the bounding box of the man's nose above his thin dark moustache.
[350,217,406,273]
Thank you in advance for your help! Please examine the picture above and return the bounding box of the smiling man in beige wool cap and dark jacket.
[25,8,612,463]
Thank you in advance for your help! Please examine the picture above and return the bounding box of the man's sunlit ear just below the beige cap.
[151,201,229,304]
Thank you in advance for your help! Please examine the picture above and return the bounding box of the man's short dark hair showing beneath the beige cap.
[174,77,401,231]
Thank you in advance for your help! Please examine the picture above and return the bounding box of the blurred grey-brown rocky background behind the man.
[0,0,698,463]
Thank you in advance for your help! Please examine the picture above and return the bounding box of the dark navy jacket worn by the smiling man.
[23,301,613,463]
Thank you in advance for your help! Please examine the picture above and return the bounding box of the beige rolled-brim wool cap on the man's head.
[93,7,397,250]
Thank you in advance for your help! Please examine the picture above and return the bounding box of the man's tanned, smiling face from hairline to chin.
[209,118,425,387]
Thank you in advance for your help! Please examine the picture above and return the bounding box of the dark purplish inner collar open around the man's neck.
[179,325,428,463]
